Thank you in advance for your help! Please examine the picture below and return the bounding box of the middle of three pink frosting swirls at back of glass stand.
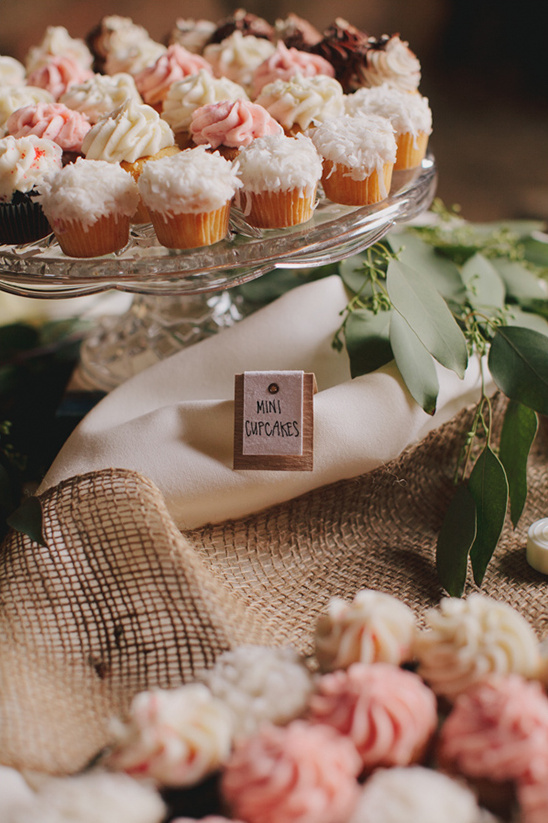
[135,43,213,106]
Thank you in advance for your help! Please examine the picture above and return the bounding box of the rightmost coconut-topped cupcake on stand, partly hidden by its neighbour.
[346,83,432,170]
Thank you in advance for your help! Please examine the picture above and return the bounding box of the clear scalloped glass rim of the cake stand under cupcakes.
[0,155,437,298]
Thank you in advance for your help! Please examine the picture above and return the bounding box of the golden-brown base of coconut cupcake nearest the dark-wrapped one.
[54,214,129,257]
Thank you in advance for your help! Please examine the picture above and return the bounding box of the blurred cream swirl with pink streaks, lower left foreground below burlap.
[108,684,232,786]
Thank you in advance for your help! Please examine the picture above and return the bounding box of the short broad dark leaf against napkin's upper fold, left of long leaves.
[344,309,394,377]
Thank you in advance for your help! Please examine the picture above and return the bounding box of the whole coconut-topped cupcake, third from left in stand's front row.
[234,134,322,229]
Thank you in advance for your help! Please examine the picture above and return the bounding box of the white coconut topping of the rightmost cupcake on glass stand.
[345,83,432,136]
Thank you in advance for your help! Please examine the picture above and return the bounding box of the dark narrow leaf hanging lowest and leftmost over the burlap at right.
[436,483,476,597]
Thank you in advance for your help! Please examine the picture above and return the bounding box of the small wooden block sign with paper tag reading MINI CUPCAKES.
[234,371,318,471]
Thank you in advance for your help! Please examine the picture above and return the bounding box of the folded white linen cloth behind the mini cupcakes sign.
[39,275,492,530]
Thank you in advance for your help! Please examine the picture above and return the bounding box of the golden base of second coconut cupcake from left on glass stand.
[150,202,230,249]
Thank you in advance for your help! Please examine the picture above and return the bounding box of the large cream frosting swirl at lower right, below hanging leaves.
[415,592,540,700]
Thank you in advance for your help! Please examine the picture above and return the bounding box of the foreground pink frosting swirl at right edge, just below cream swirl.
[438,674,548,782]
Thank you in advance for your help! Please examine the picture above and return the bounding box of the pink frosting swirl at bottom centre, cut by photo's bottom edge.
[221,720,360,823]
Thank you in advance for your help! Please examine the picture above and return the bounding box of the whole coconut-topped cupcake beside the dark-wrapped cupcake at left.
[35,156,139,257]
